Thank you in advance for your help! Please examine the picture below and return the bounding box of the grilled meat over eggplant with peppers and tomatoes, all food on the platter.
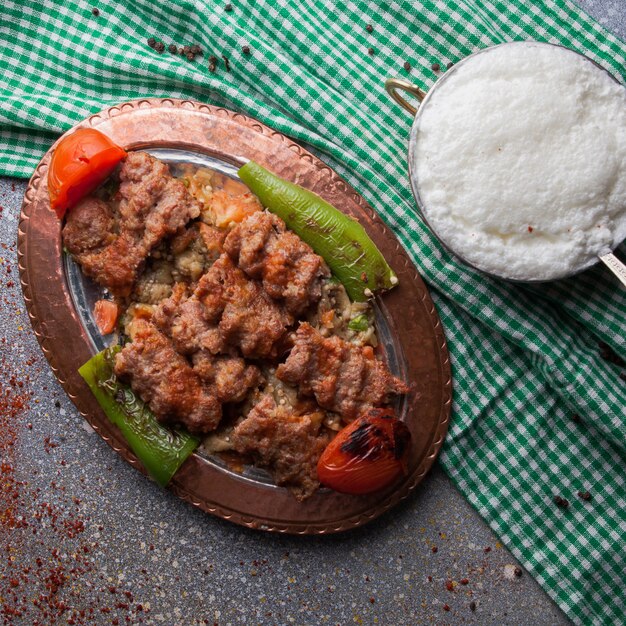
[48,129,410,500]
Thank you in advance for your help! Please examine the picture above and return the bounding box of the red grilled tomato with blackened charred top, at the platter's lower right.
[317,409,411,495]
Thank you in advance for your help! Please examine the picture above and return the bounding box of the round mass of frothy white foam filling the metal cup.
[412,42,626,280]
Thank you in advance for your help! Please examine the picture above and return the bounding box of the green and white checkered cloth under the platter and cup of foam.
[0,0,626,624]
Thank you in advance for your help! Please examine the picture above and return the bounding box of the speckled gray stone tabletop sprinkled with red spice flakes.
[0,0,626,626]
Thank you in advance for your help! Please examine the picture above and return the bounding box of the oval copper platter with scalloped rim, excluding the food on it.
[18,99,452,534]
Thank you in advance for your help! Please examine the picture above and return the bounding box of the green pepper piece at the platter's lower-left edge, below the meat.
[78,346,199,486]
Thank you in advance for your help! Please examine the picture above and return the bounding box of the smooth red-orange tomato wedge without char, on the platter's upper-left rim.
[48,128,126,219]
